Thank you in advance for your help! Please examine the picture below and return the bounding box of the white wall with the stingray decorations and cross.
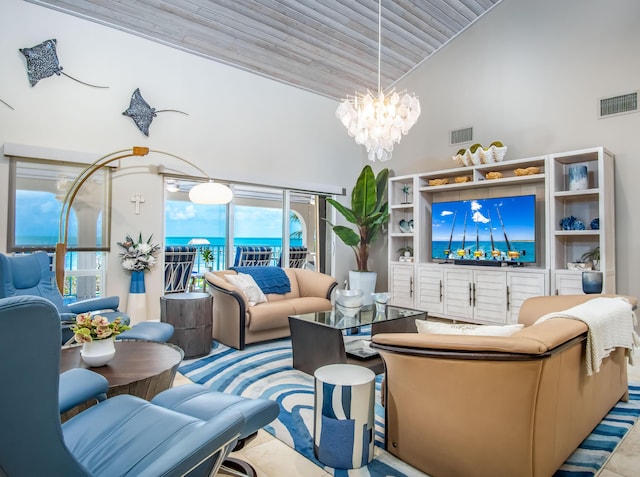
[0,0,362,317]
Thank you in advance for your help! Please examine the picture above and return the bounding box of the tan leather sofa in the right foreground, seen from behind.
[372,295,637,477]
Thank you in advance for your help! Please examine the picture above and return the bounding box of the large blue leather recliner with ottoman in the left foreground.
[0,296,279,477]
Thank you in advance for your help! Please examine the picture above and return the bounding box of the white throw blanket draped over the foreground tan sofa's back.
[535,297,639,376]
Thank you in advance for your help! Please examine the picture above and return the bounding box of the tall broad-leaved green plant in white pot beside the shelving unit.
[327,165,389,304]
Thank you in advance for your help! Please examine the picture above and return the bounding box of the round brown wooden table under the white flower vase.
[60,341,184,419]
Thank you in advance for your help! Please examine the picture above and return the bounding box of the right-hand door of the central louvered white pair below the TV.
[472,270,507,325]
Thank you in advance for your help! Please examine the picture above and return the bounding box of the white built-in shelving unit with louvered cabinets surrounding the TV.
[389,147,615,323]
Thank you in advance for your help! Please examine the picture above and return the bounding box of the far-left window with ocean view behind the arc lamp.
[7,158,110,300]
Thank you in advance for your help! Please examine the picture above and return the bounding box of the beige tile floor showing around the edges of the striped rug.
[174,350,640,477]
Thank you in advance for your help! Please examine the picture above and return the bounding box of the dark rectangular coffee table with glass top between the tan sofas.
[289,305,427,375]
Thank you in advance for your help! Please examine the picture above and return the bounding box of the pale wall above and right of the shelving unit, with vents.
[391,0,640,296]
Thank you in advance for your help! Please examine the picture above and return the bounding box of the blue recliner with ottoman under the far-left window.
[0,252,173,343]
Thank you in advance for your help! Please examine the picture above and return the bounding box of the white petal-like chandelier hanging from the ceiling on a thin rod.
[336,0,420,162]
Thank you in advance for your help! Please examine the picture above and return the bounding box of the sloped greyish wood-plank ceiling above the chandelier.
[28,0,502,99]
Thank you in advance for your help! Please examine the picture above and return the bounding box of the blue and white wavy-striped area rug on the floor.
[179,339,640,477]
